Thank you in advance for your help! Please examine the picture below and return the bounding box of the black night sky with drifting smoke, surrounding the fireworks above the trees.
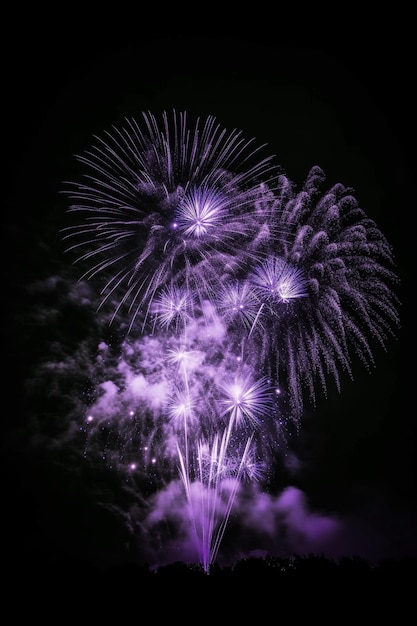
[2,20,417,565]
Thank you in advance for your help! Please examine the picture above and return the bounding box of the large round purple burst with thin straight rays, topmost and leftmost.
[61,111,276,328]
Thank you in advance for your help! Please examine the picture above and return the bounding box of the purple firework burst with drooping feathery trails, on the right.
[240,167,399,420]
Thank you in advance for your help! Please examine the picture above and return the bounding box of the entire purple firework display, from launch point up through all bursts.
[64,111,399,571]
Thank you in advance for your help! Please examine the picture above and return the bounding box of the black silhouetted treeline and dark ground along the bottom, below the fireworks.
[8,555,417,626]
